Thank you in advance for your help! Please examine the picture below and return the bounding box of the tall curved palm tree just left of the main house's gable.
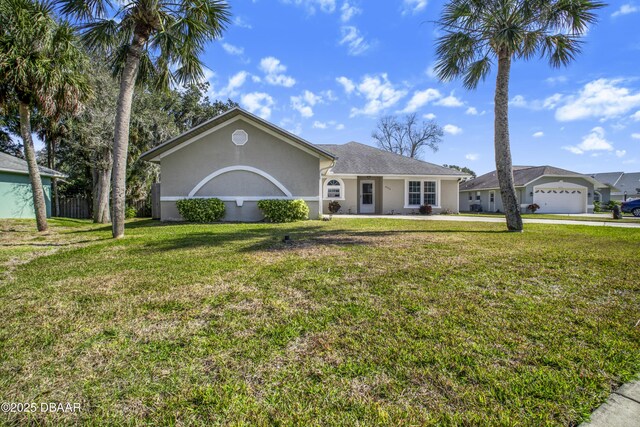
[58,0,230,238]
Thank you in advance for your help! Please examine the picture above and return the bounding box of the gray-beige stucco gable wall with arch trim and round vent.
[160,118,320,221]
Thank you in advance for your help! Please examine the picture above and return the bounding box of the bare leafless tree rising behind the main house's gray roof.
[371,113,444,158]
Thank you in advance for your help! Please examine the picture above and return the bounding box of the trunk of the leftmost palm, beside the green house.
[20,102,48,231]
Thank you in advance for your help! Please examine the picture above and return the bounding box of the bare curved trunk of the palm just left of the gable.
[111,34,145,239]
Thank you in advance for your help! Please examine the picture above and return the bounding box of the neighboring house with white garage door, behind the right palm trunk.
[460,166,606,213]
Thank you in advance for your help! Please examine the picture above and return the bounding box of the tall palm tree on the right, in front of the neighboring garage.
[435,0,605,231]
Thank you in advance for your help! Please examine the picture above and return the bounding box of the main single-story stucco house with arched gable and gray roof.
[141,108,467,221]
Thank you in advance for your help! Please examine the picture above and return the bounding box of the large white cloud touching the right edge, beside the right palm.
[556,79,640,122]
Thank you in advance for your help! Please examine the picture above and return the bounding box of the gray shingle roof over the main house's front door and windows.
[318,142,468,177]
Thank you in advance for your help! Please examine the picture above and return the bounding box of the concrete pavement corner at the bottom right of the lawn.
[580,380,640,427]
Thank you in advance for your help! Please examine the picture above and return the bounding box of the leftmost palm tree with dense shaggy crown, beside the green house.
[0,0,90,231]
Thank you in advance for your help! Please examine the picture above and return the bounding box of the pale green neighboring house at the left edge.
[0,152,65,218]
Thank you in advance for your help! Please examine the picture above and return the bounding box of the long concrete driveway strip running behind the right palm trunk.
[333,215,640,229]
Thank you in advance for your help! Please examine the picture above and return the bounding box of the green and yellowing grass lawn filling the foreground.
[0,219,640,426]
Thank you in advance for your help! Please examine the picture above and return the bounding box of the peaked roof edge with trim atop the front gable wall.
[140,107,334,162]
